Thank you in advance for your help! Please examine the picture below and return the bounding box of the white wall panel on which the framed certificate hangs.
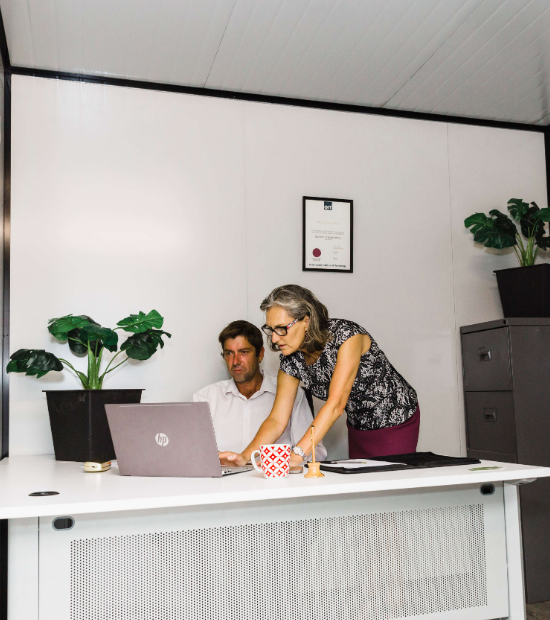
[245,104,460,454]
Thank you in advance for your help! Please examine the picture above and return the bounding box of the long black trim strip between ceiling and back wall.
[11,67,545,132]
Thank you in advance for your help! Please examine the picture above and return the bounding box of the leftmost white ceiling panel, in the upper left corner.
[0,0,235,86]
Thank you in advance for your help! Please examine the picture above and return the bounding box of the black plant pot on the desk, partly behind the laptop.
[44,390,143,463]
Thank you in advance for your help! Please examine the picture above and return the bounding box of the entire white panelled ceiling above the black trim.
[0,0,550,125]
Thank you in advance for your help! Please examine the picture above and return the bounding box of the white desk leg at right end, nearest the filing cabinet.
[504,483,526,620]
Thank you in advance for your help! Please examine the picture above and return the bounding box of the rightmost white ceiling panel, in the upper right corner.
[387,0,550,123]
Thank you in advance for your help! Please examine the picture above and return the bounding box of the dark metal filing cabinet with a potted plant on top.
[460,318,550,603]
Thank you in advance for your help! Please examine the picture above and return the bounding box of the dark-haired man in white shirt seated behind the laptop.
[193,321,327,461]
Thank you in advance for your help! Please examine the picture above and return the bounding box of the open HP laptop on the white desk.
[105,403,253,478]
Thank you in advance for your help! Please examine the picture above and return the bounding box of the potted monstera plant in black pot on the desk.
[6,310,171,463]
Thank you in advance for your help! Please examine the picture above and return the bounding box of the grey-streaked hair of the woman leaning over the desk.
[260,284,331,353]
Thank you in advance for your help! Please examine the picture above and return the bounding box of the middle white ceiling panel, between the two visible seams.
[207,0,483,106]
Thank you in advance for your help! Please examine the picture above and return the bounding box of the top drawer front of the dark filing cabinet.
[462,327,512,392]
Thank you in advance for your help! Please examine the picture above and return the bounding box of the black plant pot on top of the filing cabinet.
[495,263,550,318]
